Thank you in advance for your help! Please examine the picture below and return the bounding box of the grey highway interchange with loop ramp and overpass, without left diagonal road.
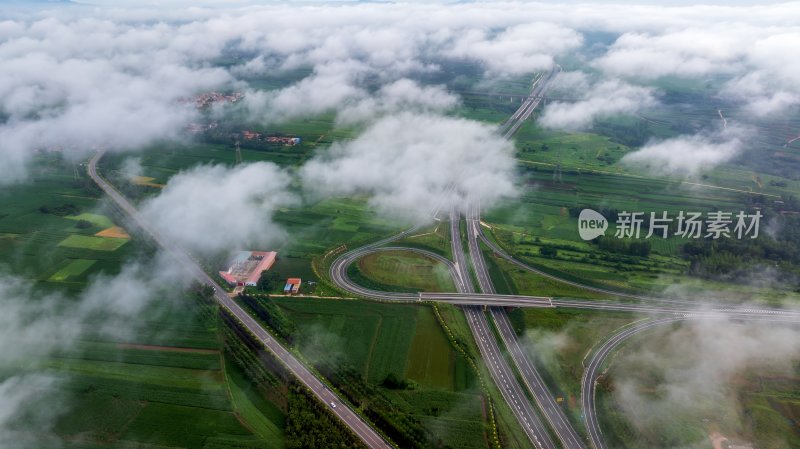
[324,67,800,449]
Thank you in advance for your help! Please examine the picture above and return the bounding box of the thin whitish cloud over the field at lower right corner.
[612,321,800,447]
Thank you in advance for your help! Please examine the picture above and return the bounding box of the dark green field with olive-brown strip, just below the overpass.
[272,297,468,391]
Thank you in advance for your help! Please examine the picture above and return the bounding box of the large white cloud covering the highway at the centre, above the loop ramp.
[300,113,515,221]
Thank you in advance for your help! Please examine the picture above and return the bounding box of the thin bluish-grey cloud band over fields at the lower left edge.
[0,257,195,449]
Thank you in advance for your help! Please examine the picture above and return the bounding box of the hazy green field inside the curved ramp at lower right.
[597,324,800,449]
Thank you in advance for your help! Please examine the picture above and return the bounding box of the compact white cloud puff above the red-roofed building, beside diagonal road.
[141,162,297,254]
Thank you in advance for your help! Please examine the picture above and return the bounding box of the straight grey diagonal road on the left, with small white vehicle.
[87,152,393,449]
